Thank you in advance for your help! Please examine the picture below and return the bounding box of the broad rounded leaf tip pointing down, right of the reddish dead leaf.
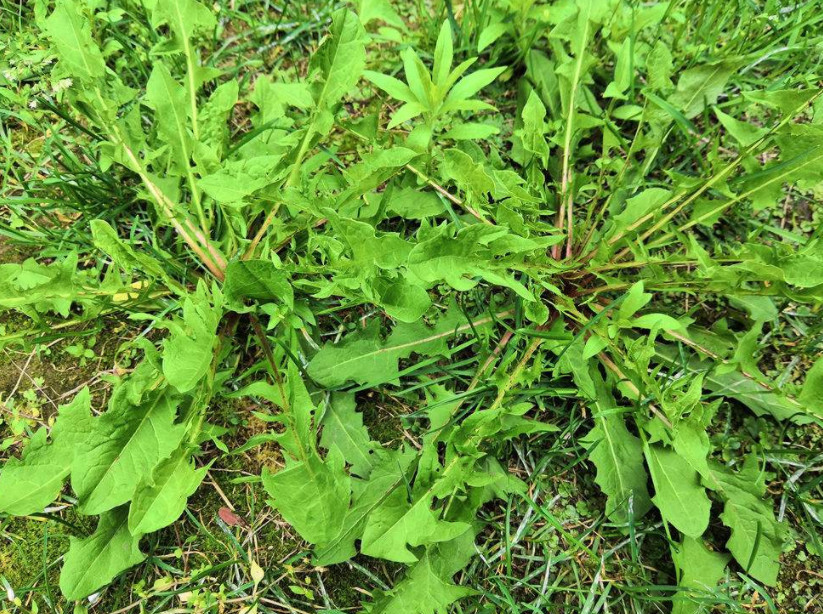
[263,447,351,544]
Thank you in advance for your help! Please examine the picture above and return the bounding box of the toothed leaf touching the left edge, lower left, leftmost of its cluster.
[0,388,92,516]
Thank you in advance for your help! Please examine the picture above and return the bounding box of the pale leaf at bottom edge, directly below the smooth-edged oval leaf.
[672,537,731,614]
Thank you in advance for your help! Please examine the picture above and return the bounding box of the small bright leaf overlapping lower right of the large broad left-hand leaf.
[128,446,207,535]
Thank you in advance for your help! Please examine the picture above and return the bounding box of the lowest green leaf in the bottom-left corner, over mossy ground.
[60,507,146,601]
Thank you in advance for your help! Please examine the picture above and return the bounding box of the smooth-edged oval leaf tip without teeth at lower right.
[646,445,712,537]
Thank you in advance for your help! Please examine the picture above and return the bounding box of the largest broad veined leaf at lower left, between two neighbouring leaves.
[71,385,184,514]
